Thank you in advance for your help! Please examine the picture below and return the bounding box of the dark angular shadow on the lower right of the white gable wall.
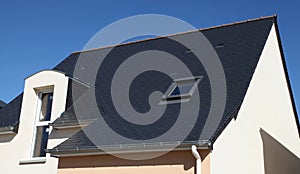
[260,129,300,174]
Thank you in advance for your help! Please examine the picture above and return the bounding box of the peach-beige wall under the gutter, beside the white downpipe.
[58,150,210,174]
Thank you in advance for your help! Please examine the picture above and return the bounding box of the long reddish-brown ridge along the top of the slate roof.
[71,14,277,55]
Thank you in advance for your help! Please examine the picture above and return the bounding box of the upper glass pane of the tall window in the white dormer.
[40,92,53,121]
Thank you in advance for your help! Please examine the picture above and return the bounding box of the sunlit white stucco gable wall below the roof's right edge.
[211,26,300,174]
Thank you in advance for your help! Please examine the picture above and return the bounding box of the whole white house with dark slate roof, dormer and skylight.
[0,16,300,174]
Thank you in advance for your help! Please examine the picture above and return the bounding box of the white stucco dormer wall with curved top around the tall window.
[0,70,68,174]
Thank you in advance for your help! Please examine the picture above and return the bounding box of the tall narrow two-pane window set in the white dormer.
[32,92,53,157]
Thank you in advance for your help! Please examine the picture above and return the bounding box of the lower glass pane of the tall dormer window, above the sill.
[33,126,49,157]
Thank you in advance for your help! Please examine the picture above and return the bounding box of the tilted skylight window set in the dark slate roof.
[160,76,203,104]
